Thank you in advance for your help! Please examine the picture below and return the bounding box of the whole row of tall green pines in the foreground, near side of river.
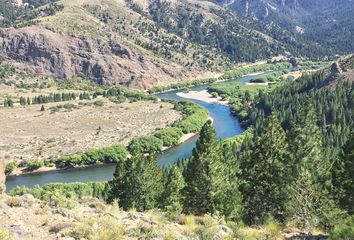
[108,102,354,230]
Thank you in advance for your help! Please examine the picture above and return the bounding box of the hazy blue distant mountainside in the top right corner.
[225,0,354,54]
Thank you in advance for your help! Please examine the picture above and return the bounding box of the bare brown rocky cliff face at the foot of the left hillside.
[0,26,199,88]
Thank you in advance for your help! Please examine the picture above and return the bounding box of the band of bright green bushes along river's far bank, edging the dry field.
[6,101,209,175]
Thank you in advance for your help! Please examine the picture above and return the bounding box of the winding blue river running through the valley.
[6,70,278,191]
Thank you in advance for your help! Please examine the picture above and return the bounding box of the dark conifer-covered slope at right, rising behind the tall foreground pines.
[249,55,354,149]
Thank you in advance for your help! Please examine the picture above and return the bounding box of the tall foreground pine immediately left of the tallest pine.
[240,112,290,224]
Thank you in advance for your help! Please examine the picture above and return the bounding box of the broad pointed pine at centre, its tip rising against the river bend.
[183,121,241,219]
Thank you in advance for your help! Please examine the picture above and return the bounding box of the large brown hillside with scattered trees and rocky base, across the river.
[0,0,324,88]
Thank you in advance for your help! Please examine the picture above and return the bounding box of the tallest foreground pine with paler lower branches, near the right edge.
[287,101,336,229]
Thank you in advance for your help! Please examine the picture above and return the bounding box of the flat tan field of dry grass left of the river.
[0,99,180,161]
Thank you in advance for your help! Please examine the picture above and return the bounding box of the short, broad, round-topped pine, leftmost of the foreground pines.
[108,153,162,211]
